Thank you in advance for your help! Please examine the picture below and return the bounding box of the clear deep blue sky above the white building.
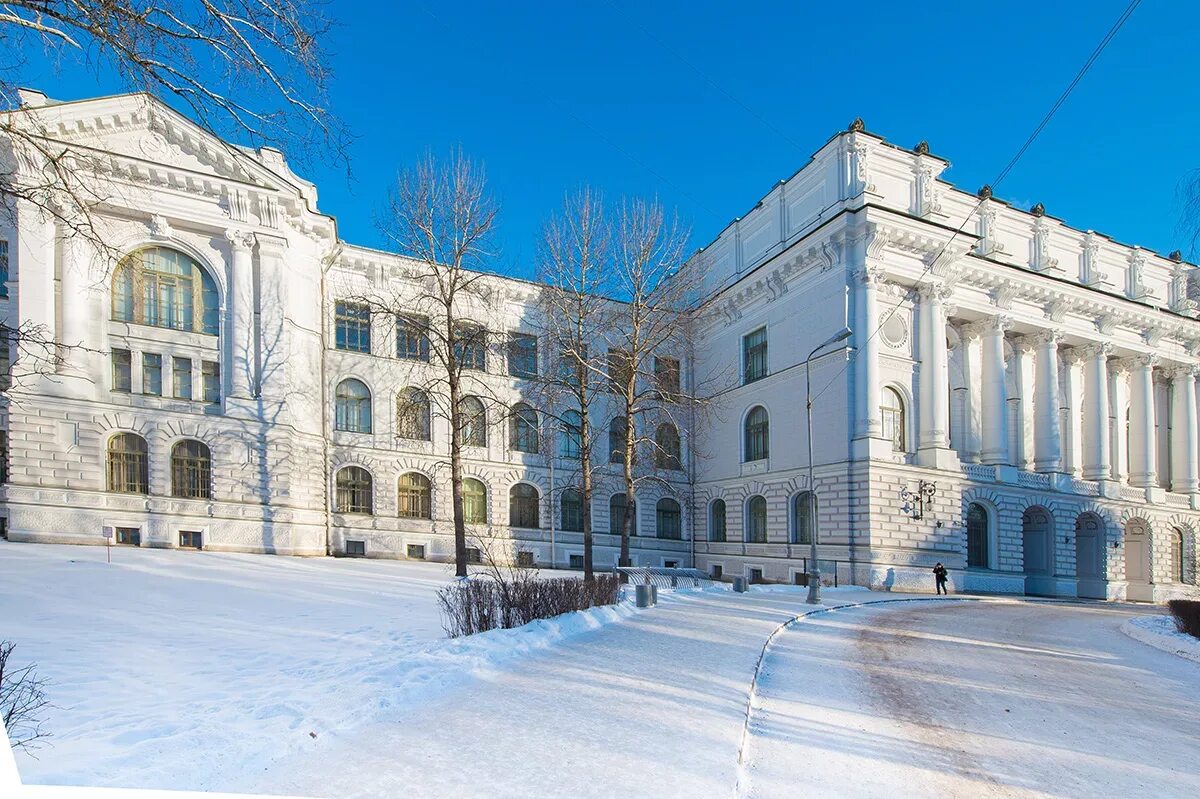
[9,0,1200,275]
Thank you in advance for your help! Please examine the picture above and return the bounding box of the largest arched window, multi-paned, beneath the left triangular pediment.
[113,247,218,336]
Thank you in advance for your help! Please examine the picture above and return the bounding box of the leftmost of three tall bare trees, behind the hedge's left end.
[358,147,498,577]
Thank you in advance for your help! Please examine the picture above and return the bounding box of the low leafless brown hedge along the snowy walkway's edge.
[438,571,619,638]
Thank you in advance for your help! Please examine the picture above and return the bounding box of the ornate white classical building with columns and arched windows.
[0,92,1200,600]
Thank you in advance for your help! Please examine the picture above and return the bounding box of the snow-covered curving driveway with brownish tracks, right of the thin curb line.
[749,602,1200,799]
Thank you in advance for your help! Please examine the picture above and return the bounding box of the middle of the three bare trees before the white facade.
[536,190,614,579]
